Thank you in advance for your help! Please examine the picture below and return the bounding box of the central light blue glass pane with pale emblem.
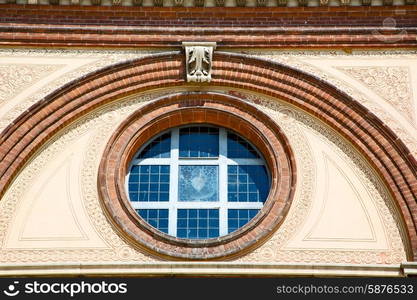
[178,166,219,201]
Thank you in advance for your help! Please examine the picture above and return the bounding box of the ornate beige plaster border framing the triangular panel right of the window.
[228,92,407,264]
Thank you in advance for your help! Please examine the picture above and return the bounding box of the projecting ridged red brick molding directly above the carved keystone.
[0,23,417,50]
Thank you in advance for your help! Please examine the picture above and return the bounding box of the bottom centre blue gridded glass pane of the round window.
[177,209,219,239]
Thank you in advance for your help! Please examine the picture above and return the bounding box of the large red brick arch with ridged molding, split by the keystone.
[0,51,417,261]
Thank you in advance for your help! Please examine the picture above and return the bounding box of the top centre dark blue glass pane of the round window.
[179,127,219,158]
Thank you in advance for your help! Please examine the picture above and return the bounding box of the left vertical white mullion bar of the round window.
[168,128,179,236]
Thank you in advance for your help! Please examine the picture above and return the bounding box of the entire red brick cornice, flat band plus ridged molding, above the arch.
[0,4,417,50]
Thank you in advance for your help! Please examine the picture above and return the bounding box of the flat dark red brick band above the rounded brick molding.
[0,4,417,28]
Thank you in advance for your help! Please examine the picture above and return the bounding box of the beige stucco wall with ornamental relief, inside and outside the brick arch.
[0,50,417,274]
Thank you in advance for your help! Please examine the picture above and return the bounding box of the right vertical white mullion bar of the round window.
[219,128,228,236]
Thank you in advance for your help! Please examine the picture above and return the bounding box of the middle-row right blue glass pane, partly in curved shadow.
[227,165,269,202]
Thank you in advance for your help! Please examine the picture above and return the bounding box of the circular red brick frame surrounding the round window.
[98,92,296,260]
